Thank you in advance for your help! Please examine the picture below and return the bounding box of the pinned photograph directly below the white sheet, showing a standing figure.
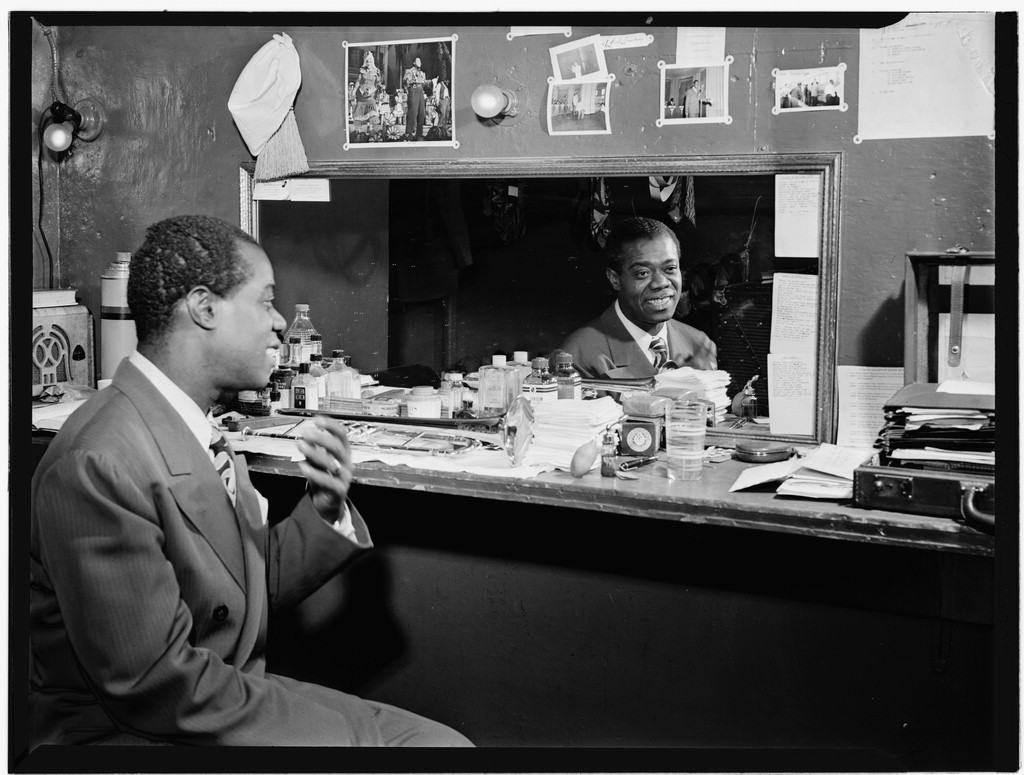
[654,55,732,127]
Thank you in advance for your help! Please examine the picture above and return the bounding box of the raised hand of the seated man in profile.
[298,417,352,523]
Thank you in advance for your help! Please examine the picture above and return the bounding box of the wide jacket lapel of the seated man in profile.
[112,360,248,589]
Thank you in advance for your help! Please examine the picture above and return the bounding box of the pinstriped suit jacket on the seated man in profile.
[30,360,380,745]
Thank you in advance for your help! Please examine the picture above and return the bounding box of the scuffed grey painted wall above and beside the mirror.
[33,20,995,374]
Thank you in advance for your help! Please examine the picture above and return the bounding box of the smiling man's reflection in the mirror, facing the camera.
[551,218,718,379]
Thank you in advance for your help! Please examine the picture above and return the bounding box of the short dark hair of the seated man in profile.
[128,215,258,344]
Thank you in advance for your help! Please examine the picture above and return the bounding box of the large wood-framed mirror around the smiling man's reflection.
[240,154,841,443]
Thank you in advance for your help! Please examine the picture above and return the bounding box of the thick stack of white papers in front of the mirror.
[523,395,623,471]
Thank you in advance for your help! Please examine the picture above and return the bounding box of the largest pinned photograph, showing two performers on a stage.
[342,35,459,150]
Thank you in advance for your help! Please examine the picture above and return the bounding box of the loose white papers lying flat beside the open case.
[729,444,874,500]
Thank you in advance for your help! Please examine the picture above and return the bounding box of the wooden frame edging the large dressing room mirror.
[239,153,843,444]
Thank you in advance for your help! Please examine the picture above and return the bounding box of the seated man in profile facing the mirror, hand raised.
[30,216,470,746]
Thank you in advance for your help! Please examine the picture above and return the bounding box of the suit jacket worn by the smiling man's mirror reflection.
[551,302,717,379]
